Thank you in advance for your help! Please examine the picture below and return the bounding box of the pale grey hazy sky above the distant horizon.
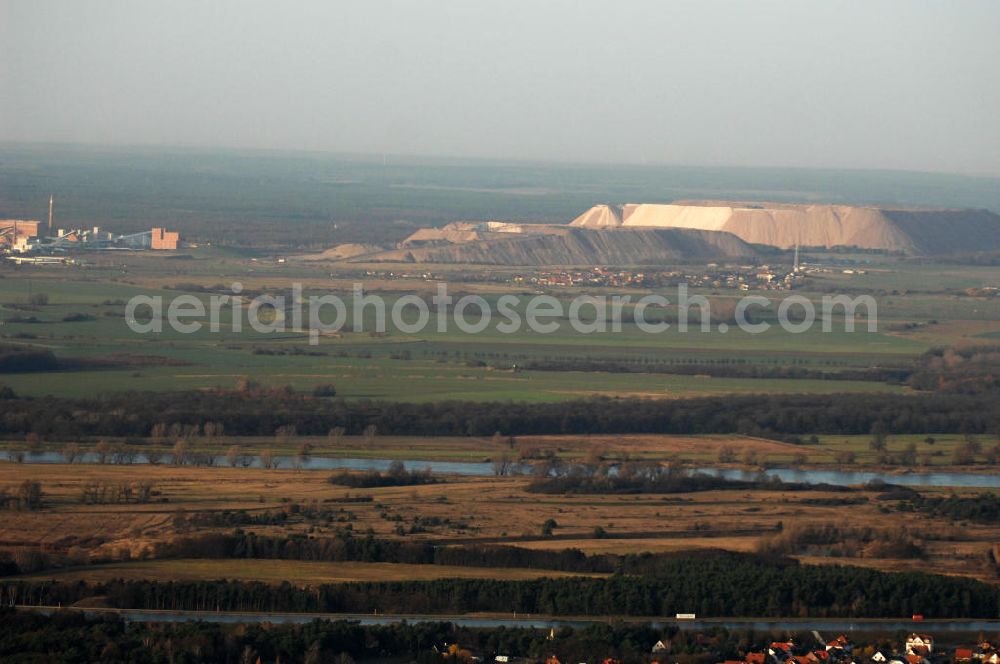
[0,0,1000,175]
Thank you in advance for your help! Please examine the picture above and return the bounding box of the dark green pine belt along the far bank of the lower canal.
[0,554,1000,618]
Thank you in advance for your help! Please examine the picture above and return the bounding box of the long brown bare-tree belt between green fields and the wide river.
[0,390,1000,441]
